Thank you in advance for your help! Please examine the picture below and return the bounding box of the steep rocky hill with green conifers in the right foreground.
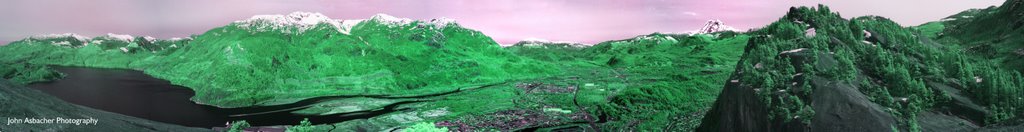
[698,1,1024,131]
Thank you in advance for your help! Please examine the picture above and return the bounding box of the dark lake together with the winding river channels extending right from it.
[29,67,418,128]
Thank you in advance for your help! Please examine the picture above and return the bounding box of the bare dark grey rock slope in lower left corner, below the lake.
[0,79,213,132]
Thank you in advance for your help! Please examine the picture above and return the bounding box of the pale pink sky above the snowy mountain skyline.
[0,0,1004,44]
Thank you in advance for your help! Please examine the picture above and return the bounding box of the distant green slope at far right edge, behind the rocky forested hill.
[933,0,1024,72]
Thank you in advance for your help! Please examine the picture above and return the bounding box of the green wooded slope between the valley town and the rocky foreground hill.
[509,32,749,130]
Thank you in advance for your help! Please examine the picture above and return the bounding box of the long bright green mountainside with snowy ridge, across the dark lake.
[0,15,560,107]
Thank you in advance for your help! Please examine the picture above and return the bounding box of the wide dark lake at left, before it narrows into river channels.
[29,67,227,127]
